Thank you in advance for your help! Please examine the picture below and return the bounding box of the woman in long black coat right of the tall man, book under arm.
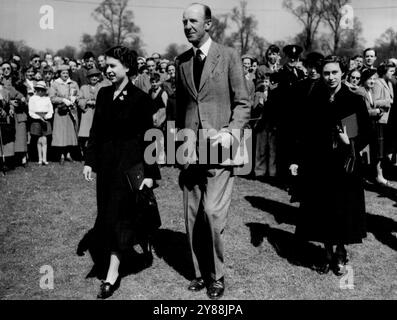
[290,57,370,275]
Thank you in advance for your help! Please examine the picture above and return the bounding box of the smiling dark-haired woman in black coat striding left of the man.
[83,47,160,299]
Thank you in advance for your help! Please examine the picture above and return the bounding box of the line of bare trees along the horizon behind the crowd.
[0,0,397,61]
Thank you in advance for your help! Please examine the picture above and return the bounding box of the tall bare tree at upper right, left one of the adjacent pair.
[283,0,324,51]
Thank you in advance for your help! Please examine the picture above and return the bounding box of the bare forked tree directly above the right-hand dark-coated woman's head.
[321,0,349,54]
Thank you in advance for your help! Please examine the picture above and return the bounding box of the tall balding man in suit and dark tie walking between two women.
[176,4,251,299]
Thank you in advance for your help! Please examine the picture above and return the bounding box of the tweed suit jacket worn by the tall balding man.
[176,42,251,139]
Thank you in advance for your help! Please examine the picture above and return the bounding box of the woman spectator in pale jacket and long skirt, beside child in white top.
[49,65,79,164]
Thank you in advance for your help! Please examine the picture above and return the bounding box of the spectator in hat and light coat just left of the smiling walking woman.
[78,68,102,155]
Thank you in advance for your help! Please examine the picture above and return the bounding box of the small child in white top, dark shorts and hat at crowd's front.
[29,81,54,165]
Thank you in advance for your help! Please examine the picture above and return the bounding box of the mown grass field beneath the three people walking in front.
[0,162,397,300]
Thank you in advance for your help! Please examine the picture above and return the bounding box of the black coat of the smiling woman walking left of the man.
[85,82,160,259]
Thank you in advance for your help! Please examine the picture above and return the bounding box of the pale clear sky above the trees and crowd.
[0,0,397,54]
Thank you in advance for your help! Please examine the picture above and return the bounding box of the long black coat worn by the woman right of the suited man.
[295,83,370,244]
